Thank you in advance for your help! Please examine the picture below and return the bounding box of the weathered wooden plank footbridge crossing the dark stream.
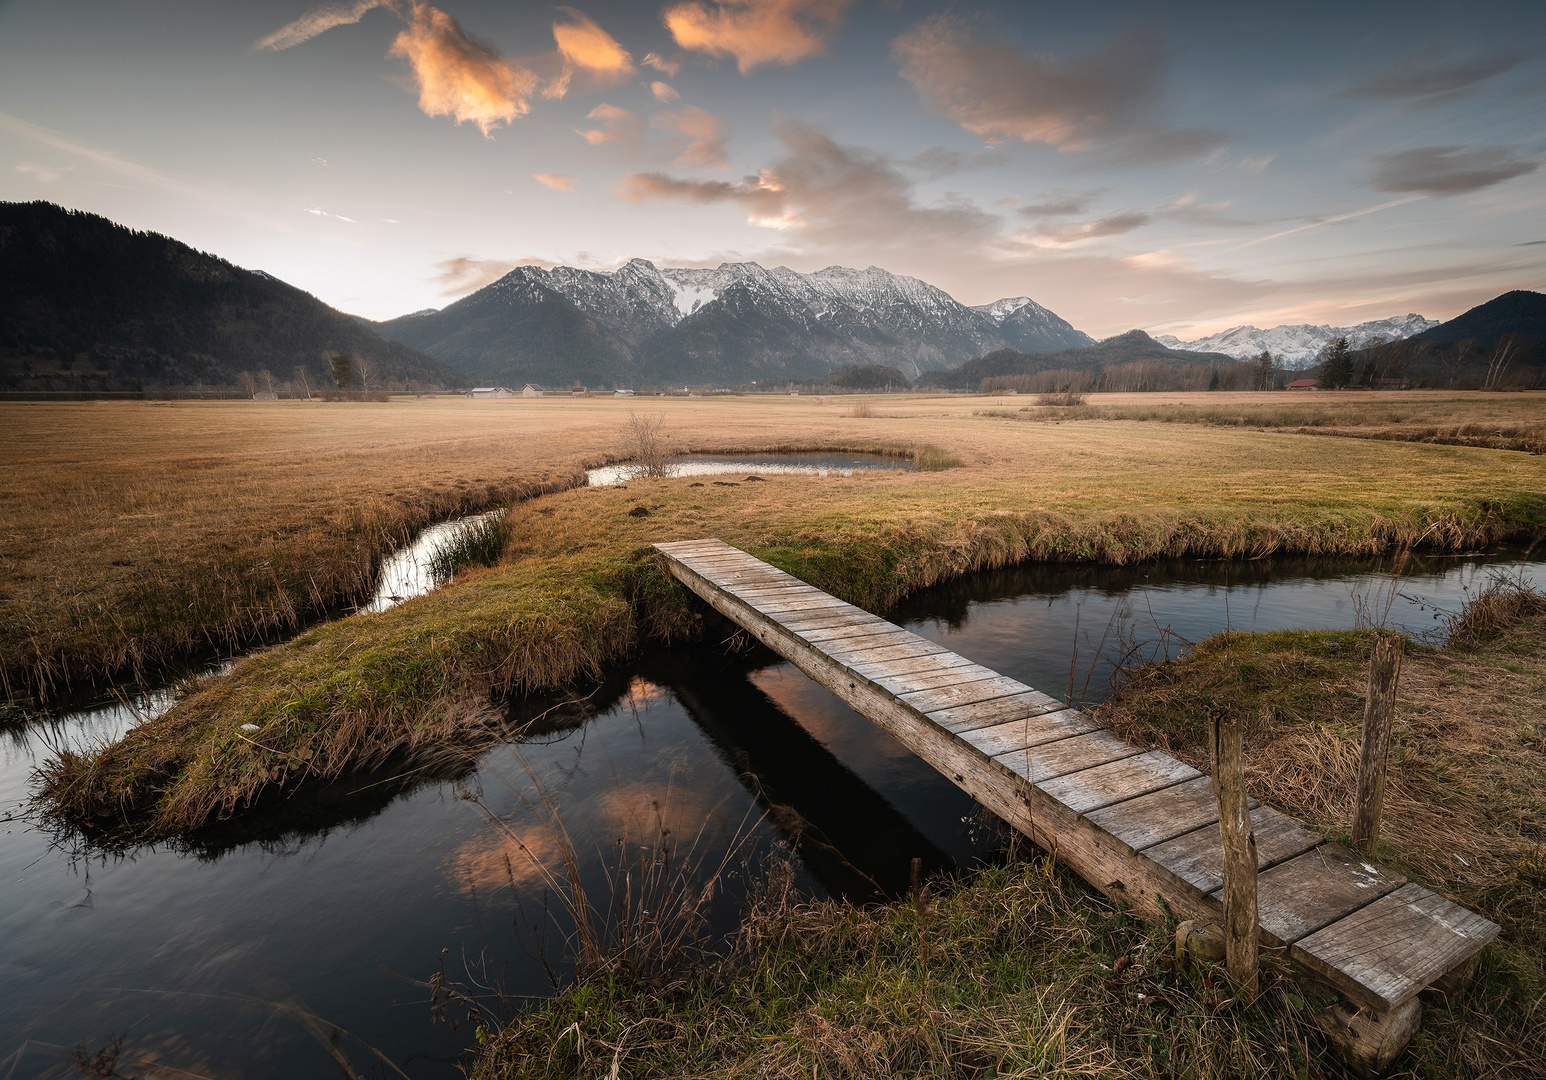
[656,539,1498,1072]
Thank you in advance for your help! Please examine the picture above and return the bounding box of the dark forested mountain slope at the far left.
[0,202,465,389]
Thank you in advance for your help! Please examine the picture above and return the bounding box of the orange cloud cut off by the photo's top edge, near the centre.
[665,0,853,74]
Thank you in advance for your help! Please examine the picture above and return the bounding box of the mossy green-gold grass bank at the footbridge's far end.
[43,420,1546,842]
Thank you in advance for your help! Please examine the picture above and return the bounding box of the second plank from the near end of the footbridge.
[1236,844,1407,946]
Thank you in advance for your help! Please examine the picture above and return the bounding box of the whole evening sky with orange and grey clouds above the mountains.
[0,0,1546,338]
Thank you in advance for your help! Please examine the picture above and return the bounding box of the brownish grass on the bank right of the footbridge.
[1098,579,1546,1077]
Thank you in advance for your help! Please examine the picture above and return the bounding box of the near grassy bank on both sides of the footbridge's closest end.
[475,589,1546,1080]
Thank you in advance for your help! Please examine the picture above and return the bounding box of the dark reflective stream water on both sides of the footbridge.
[0,553,1546,1077]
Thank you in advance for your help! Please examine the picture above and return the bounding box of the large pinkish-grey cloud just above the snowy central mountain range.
[620,121,1002,250]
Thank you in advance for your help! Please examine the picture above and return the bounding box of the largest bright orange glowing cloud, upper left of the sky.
[388,3,536,139]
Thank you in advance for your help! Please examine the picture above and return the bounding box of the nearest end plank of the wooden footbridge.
[1292,884,1498,1010]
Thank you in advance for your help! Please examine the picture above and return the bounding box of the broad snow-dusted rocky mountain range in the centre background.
[376,260,1093,386]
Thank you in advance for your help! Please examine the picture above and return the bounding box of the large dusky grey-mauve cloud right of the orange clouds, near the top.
[892,15,1228,164]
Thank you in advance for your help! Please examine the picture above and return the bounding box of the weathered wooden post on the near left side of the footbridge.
[1209,715,1257,1000]
